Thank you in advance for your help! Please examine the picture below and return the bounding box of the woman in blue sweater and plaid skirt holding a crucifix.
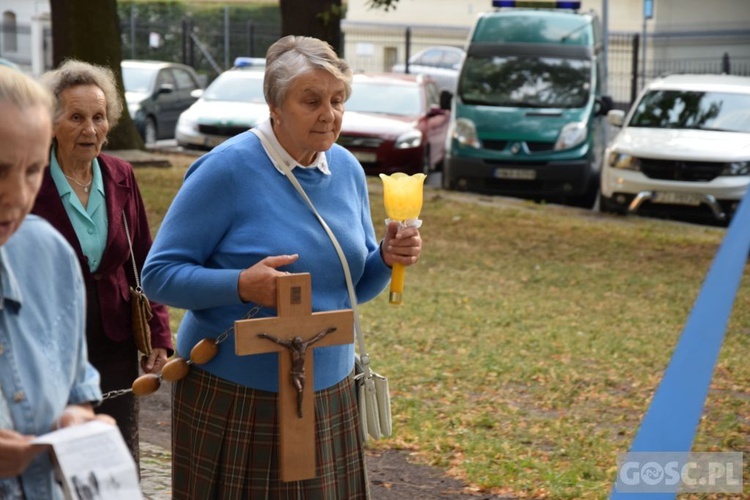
[143,36,422,499]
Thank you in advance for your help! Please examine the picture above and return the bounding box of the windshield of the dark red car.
[345,81,422,116]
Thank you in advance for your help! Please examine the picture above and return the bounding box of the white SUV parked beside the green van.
[599,75,750,224]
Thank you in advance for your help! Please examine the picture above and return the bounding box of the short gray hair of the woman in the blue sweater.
[263,35,352,107]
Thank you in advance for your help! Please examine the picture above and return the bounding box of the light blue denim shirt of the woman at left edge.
[0,215,102,499]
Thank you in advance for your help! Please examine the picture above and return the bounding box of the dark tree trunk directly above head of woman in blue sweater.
[279,0,343,55]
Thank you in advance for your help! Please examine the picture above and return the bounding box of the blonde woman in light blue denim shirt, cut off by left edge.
[0,66,114,500]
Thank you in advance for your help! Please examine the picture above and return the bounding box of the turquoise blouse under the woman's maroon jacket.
[49,148,107,273]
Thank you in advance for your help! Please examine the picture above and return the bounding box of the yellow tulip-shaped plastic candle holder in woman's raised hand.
[380,172,427,305]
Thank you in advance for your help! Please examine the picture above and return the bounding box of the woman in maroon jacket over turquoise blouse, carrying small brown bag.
[33,60,172,464]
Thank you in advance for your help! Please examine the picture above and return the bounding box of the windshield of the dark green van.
[458,56,591,108]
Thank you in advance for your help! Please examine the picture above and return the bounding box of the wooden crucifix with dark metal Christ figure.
[234,273,354,482]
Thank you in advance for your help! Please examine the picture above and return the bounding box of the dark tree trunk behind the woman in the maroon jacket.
[50,0,143,149]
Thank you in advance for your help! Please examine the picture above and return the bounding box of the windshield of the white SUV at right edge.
[628,90,750,133]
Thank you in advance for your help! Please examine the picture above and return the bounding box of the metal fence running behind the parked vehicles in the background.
[0,13,750,109]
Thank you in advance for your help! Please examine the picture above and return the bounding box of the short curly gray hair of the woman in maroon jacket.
[41,59,122,130]
